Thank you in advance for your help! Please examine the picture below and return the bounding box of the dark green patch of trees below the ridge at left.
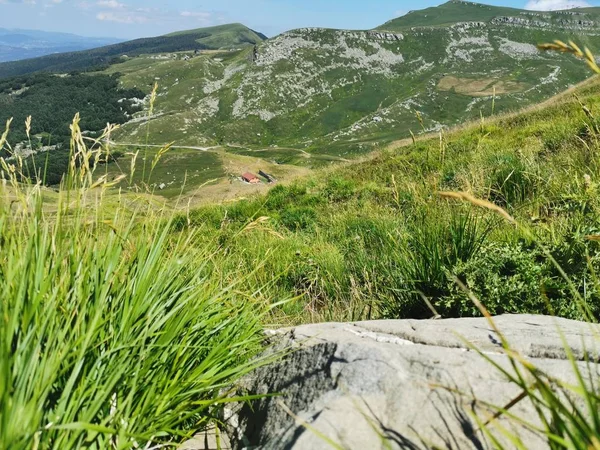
[0,74,145,184]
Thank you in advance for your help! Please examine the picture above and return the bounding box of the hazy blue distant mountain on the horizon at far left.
[0,28,119,62]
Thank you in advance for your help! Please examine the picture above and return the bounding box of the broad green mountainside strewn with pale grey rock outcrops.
[108,1,600,158]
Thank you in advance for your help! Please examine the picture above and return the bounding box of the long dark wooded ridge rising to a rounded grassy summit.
[0,24,265,79]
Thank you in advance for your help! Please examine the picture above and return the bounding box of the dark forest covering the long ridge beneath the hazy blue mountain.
[0,32,210,79]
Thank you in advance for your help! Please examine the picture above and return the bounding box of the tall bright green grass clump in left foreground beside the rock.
[0,118,266,450]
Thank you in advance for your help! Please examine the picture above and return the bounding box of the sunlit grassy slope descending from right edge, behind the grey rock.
[181,79,600,322]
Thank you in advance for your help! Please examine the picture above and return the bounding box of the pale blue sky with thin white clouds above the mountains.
[0,0,600,39]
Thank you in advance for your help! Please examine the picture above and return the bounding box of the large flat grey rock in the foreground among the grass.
[231,315,600,450]
